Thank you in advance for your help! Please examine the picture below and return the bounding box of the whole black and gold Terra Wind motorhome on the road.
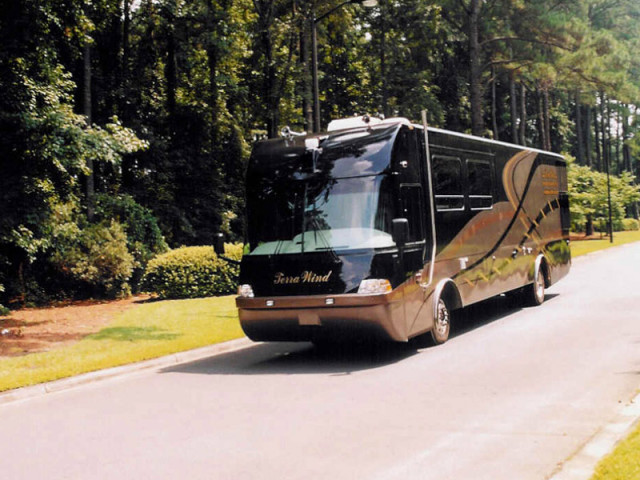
[229,117,571,343]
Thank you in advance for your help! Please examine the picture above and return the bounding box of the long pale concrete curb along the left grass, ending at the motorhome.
[0,337,257,405]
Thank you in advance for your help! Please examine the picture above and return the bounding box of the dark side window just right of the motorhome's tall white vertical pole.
[432,156,464,212]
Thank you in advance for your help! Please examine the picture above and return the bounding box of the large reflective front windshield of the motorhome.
[247,175,394,255]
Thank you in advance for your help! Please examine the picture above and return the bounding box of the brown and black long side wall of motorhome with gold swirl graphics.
[410,134,571,336]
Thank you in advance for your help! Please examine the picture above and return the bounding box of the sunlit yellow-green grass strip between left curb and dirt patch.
[0,295,244,391]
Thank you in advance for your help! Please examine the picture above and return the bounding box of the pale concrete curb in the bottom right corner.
[549,394,640,480]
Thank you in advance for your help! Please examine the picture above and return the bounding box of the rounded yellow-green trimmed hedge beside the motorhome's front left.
[142,244,243,298]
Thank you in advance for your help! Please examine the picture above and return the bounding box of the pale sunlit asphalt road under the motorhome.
[0,244,640,480]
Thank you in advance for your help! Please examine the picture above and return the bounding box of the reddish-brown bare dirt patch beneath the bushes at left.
[0,295,149,357]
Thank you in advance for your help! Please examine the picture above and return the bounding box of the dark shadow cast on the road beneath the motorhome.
[161,294,556,375]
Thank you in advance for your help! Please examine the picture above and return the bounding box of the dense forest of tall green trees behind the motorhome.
[0,0,640,304]
